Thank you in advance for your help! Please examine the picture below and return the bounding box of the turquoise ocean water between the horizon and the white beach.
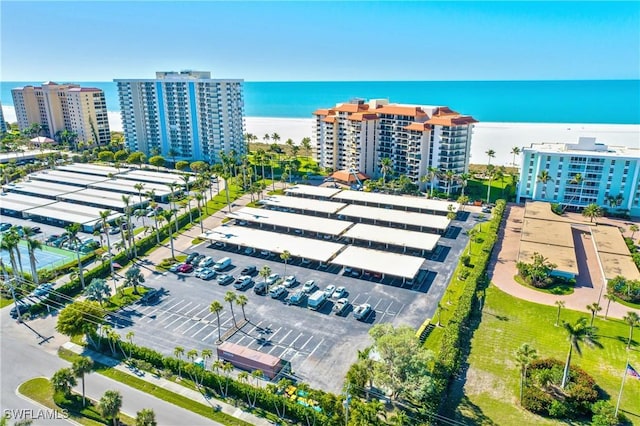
[0,80,640,124]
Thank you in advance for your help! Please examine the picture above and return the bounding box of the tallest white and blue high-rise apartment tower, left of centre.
[114,71,246,163]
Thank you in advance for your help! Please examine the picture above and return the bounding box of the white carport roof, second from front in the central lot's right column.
[343,223,440,251]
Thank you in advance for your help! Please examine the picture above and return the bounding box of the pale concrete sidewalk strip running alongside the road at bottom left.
[62,342,273,426]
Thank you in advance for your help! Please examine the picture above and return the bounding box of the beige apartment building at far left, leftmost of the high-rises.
[11,82,111,145]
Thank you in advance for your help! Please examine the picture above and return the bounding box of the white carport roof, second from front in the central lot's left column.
[227,207,353,235]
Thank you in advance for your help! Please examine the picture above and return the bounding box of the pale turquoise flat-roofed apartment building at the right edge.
[517,137,640,216]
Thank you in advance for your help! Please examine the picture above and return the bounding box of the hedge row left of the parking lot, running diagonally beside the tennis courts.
[29,209,200,315]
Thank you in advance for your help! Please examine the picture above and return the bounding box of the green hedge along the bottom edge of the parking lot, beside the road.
[92,336,344,425]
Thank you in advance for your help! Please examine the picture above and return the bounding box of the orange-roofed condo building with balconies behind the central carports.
[314,99,477,189]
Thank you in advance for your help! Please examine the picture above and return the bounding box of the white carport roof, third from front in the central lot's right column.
[338,204,451,230]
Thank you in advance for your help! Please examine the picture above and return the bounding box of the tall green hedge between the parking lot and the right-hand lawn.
[427,200,506,410]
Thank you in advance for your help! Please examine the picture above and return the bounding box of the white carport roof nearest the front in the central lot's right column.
[331,246,424,279]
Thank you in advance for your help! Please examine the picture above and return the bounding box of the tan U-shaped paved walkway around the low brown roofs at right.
[488,205,640,318]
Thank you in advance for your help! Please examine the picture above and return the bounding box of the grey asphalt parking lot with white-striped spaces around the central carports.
[107,208,476,392]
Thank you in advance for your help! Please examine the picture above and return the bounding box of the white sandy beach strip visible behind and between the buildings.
[2,106,640,166]
